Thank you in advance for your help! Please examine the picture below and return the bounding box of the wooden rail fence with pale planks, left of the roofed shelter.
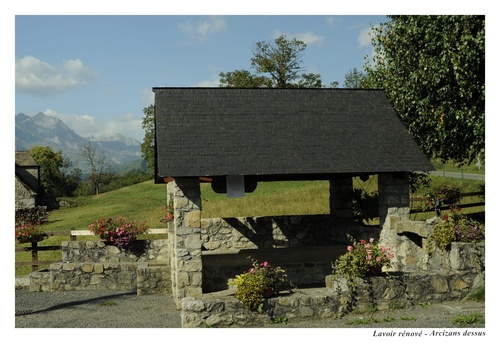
[16,229,168,272]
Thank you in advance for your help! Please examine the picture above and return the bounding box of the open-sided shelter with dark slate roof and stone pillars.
[153,87,434,306]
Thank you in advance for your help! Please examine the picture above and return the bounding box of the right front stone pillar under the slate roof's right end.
[378,173,410,227]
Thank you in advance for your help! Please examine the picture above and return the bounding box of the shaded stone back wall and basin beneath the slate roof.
[197,215,380,293]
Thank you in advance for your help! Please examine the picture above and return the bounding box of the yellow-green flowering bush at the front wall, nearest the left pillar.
[229,260,293,311]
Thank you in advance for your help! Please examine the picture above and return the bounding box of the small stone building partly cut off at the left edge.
[15,151,40,210]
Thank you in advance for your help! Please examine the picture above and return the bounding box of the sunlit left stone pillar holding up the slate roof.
[167,178,202,309]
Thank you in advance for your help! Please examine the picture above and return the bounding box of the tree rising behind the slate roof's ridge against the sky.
[219,35,328,88]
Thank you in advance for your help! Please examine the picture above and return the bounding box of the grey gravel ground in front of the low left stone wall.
[16,291,181,328]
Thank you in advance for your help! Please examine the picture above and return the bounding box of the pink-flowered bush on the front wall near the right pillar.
[332,236,394,278]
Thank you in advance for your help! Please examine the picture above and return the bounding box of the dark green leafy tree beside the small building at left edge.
[28,146,81,198]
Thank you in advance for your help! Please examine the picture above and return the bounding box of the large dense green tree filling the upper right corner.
[365,15,485,165]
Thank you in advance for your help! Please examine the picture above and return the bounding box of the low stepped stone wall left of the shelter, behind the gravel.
[30,239,172,295]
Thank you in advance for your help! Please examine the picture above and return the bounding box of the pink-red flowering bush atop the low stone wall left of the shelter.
[89,216,148,248]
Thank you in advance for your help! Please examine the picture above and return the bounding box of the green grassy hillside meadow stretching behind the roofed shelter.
[15,176,484,275]
